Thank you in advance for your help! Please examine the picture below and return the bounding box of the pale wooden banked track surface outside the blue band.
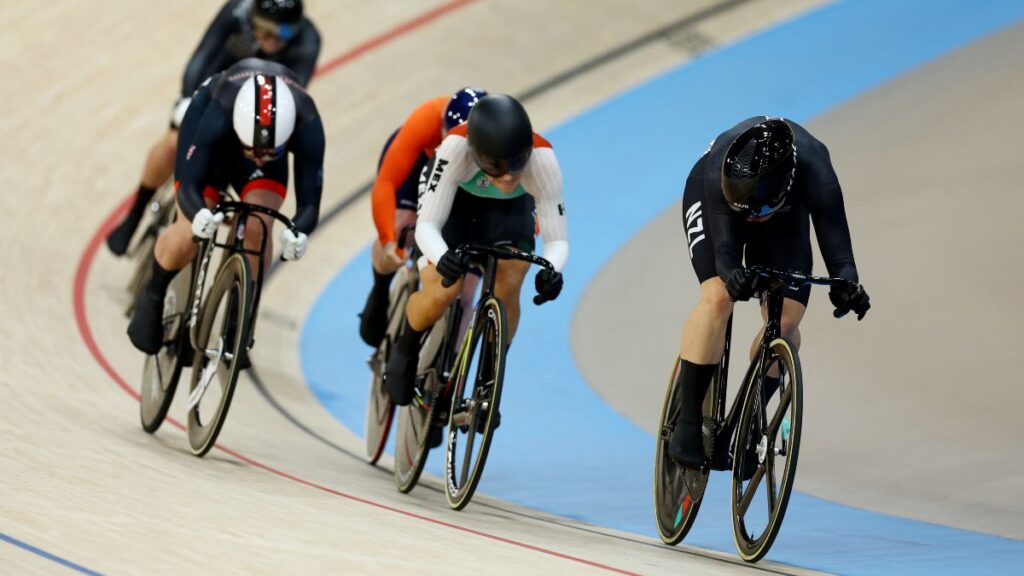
[0,0,905,574]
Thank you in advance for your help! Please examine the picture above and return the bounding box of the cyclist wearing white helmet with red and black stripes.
[128,58,325,354]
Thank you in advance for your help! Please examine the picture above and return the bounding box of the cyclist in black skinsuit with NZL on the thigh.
[669,116,870,467]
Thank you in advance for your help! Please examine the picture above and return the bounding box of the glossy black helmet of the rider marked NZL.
[722,118,797,220]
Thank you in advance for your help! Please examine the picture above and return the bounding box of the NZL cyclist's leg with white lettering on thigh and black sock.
[669,157,733,467]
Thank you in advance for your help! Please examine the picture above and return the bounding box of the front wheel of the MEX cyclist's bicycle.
[444,296,507,510]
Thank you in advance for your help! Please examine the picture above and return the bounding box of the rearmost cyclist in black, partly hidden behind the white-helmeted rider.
[106,0,321,255]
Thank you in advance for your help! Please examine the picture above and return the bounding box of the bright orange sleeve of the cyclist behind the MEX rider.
[371,96,449,245]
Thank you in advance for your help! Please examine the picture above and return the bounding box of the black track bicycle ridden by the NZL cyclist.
[654,266,849,563]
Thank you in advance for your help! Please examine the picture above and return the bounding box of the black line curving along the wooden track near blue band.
[245,0,793,575]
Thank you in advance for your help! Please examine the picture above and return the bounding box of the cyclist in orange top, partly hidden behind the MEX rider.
[359,87,487,347]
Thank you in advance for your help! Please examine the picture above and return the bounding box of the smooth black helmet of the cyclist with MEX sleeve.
[467,94,534,177]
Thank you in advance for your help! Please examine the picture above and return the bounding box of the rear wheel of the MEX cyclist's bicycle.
[394,314,449,494]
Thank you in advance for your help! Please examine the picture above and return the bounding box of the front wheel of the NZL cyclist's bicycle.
[732,338,804,562]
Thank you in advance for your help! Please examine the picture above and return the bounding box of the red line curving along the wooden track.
[72,0,636,576]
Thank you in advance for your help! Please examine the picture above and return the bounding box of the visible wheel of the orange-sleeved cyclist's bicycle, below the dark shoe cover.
[366,266,409,464]
